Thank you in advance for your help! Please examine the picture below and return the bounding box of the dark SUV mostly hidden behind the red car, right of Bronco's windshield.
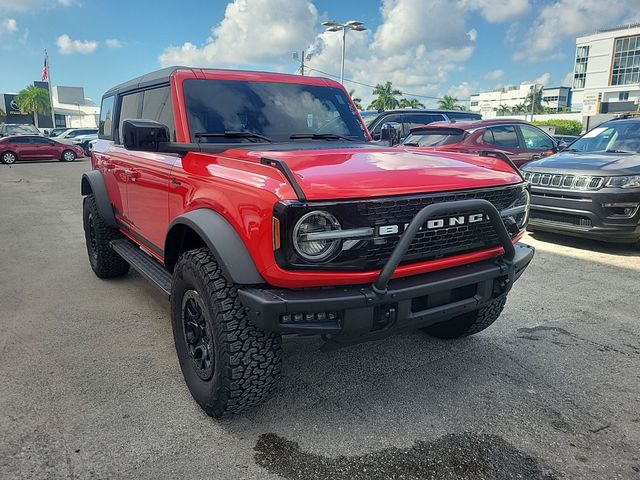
[367,108,482,140]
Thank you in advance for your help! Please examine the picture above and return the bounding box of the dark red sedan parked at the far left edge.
[0,135,84,165]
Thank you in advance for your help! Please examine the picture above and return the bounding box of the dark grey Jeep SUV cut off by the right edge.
[523,118,640,243]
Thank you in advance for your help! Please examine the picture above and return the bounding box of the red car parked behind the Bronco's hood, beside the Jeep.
[402,119,563,167]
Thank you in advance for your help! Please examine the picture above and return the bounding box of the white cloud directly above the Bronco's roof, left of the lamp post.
[159,0,318,67]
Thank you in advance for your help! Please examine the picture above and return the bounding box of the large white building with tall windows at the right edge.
[572,23,640,115]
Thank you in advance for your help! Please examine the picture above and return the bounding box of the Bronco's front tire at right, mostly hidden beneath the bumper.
[421,295,507,339]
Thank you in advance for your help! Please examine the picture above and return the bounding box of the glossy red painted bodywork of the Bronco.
[93,70,522,288]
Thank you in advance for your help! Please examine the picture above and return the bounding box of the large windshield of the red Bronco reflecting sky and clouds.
[184,80,367,143]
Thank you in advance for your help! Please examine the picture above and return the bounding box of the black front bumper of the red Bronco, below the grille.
[238,243,534,344]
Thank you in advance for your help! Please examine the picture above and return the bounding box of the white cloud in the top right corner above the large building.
[510,0,640,61]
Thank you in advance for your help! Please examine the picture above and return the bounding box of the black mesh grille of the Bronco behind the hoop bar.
[359,186,522,267]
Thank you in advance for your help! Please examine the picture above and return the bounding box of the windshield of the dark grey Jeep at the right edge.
[568,122,640,152]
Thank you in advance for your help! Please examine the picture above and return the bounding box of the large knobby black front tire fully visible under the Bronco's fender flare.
[171,248,282,418]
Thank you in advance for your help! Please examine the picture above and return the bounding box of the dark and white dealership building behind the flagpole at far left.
[0,82,100,128]
